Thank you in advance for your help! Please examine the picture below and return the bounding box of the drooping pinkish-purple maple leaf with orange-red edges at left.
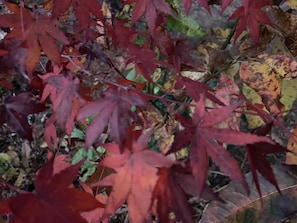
[39,66,84,145]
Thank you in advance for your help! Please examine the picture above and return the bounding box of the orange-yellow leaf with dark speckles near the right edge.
[239,54,297,114]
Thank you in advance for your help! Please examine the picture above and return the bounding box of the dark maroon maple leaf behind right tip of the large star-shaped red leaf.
[246,123,289,197]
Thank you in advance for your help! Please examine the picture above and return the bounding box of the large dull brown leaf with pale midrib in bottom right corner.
[200,166,297,223]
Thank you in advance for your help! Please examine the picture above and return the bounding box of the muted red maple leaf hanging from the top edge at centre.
[126,0,172,35]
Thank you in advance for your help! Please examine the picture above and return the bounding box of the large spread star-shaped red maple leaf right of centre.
[171,95,273,196]
